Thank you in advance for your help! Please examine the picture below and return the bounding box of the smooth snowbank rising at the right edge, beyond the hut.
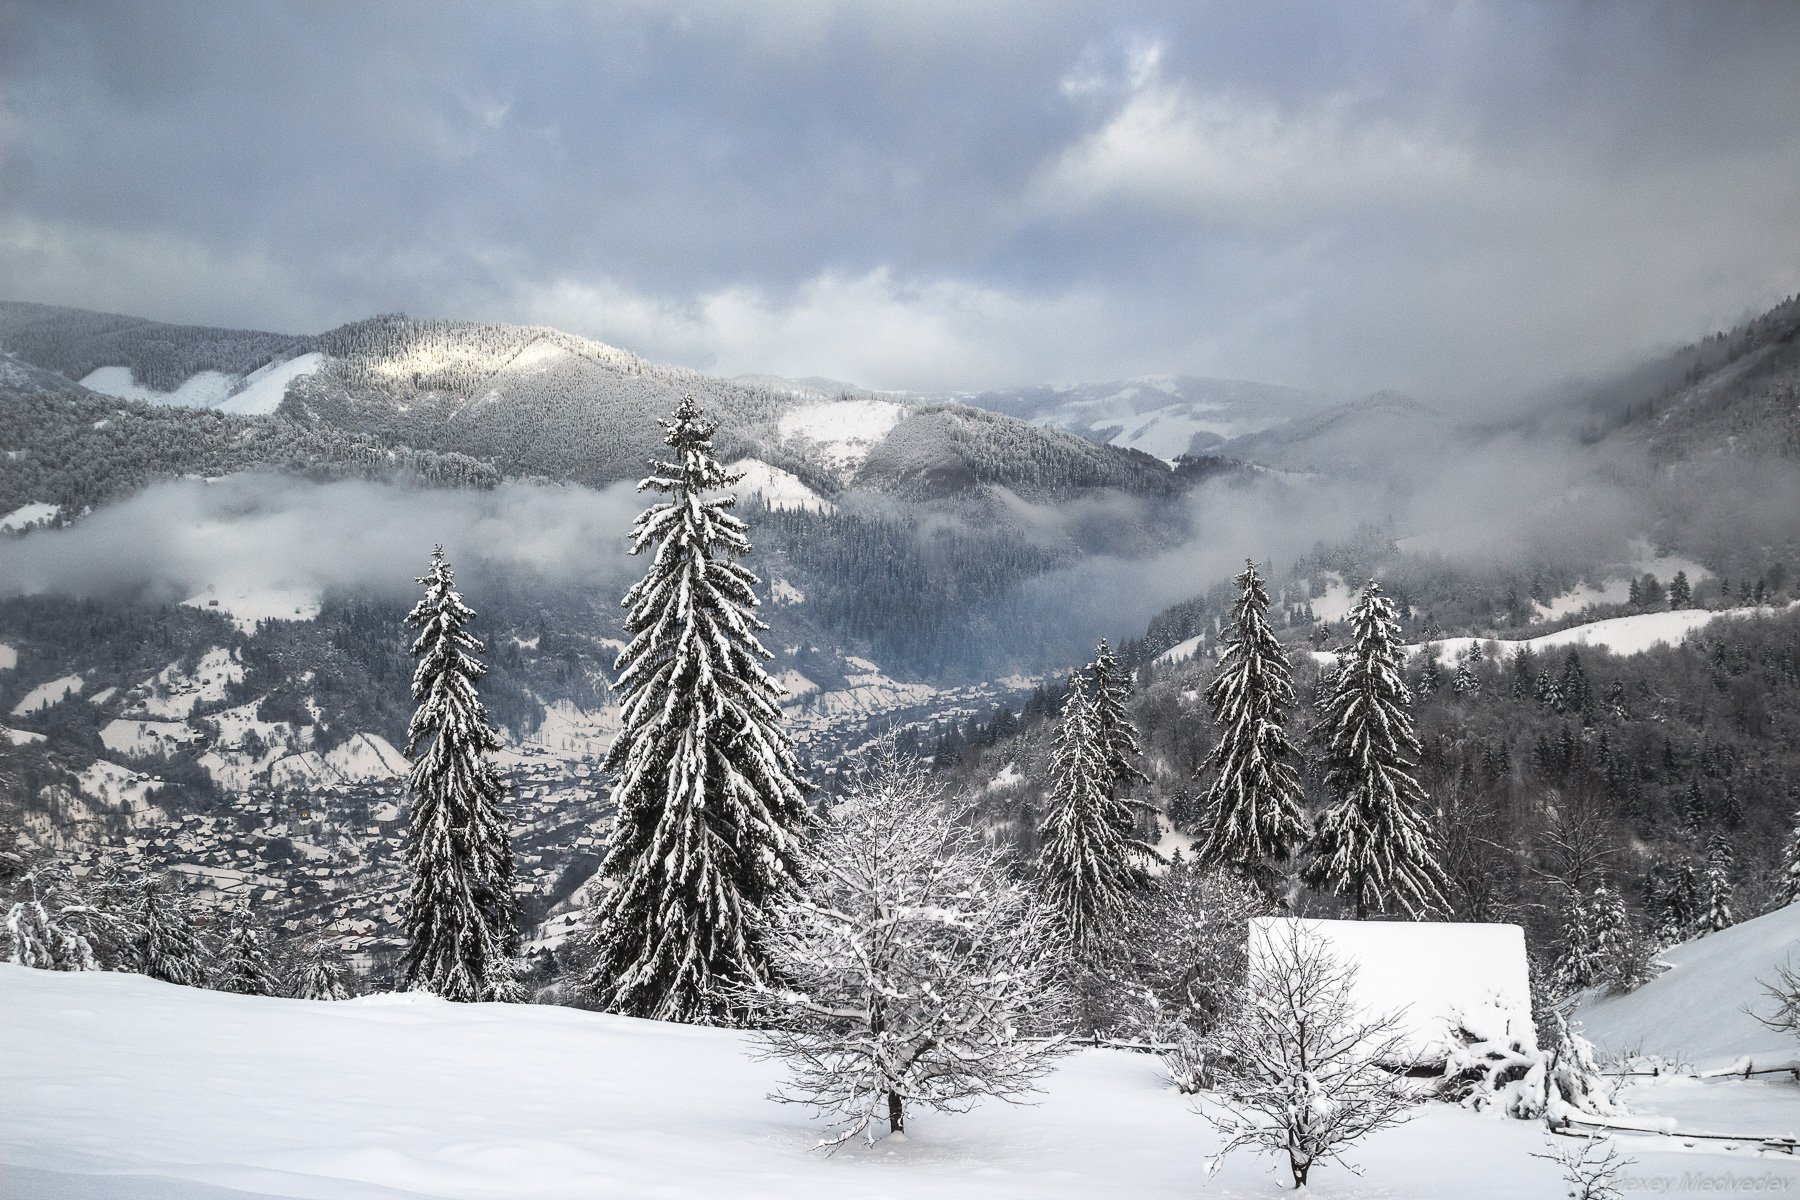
[1580,905,1800,1072]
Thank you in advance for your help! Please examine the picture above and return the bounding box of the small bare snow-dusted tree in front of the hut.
[1208,921,1420,1189]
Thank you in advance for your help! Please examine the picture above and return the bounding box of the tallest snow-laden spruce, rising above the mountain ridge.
[585,396,806,1022]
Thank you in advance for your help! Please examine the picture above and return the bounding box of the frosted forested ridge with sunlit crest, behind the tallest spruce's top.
[10,302,1209,500]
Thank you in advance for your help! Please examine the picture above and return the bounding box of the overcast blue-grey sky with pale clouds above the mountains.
[0,0,1800,398]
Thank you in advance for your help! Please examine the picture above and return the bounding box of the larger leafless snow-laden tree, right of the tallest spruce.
[736,747,1066,1146]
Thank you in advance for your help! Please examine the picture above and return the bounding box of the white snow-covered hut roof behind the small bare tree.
[1249,918,1537,1069]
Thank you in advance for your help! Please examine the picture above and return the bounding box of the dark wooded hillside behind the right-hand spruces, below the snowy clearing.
[916,597,1800,975]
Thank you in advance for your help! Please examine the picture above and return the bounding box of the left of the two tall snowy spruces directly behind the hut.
[1197,560,1307,896]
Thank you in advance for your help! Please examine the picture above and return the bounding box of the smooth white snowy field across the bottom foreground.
[0,966,1800,1200]
